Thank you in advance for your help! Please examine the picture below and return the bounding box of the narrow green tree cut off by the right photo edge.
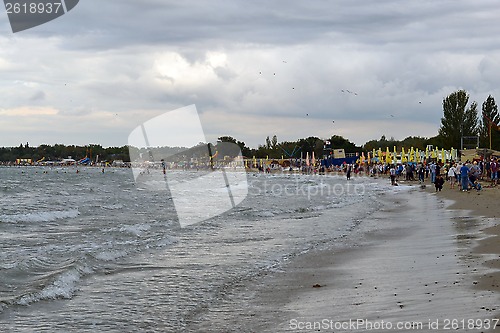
[480,95,500,149]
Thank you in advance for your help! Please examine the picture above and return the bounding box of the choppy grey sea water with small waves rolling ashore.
[0,167,490,332]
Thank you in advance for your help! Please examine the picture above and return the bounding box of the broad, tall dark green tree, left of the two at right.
[439,90,479,148]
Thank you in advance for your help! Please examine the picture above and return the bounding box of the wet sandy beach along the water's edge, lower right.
[187,180,500,332]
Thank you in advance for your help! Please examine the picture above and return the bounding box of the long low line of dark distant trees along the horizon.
[0,135,440,162]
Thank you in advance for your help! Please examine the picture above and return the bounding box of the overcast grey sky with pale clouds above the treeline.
[0,0,500,147]
